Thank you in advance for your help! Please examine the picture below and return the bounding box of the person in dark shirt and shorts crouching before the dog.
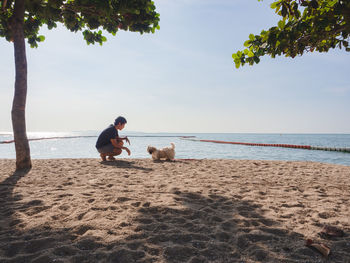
[96,116,130,161]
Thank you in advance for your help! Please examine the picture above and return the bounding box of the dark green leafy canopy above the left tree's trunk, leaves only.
[0,0,159,47]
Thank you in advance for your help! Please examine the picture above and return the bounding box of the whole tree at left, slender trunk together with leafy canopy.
[0,0,159,170]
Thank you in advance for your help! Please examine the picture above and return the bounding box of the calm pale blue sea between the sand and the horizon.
[0,131,350,166]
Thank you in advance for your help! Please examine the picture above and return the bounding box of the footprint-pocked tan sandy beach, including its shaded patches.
[0,159,350,263]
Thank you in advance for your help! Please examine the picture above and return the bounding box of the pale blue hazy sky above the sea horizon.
[0,0,350,133]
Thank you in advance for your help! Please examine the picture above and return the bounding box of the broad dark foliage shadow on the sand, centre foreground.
[124,191,310,262]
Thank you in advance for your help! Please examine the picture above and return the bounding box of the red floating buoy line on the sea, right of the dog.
[181,136,350,153]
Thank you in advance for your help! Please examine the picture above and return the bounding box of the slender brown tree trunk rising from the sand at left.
[11,0,32,170]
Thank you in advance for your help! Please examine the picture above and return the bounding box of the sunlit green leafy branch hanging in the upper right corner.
[232,0,350,68]
